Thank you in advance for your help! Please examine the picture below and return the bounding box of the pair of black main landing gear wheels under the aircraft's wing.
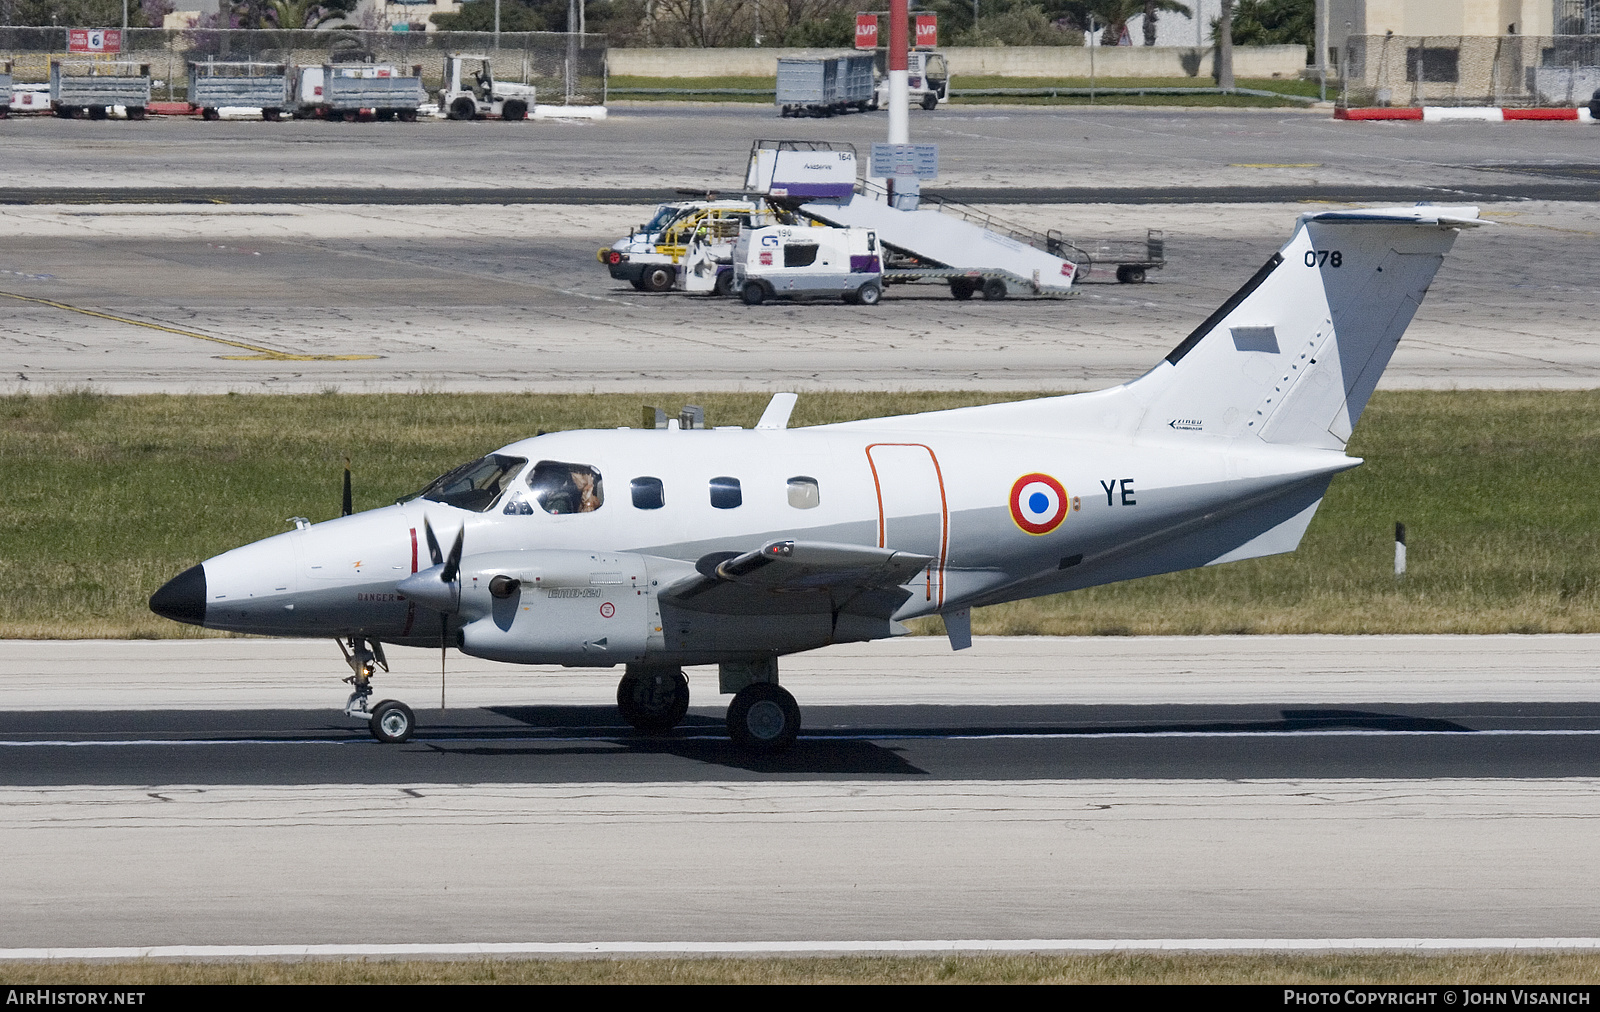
[611,658,800,756]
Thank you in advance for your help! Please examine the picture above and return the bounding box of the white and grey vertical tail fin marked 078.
[1130,207,1483,450]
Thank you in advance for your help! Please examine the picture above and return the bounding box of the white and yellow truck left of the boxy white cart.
[595,197,787,295]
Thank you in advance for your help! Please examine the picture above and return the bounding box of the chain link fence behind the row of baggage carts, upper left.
[0,27,606,106]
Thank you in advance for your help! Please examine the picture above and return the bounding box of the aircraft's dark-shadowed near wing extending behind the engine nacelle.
[661,541,933,618]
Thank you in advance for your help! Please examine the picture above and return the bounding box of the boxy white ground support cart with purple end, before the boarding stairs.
[733,224,883,306]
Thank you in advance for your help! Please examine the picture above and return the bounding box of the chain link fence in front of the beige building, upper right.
[1339,34,1600,107]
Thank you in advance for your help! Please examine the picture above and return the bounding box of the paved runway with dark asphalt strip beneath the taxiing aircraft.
[0,636,1600,951]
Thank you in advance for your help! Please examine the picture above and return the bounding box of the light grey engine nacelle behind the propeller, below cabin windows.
[461,549,664,668]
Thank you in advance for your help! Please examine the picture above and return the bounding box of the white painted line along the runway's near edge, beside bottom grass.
[0,938,1600,961]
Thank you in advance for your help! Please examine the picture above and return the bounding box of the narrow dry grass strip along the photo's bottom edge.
[0,951,1600,986]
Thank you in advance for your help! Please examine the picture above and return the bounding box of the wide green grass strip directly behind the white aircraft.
[0,391,1600,637]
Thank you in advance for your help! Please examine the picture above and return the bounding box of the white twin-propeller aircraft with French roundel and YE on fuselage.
[150,205,1482,751]
